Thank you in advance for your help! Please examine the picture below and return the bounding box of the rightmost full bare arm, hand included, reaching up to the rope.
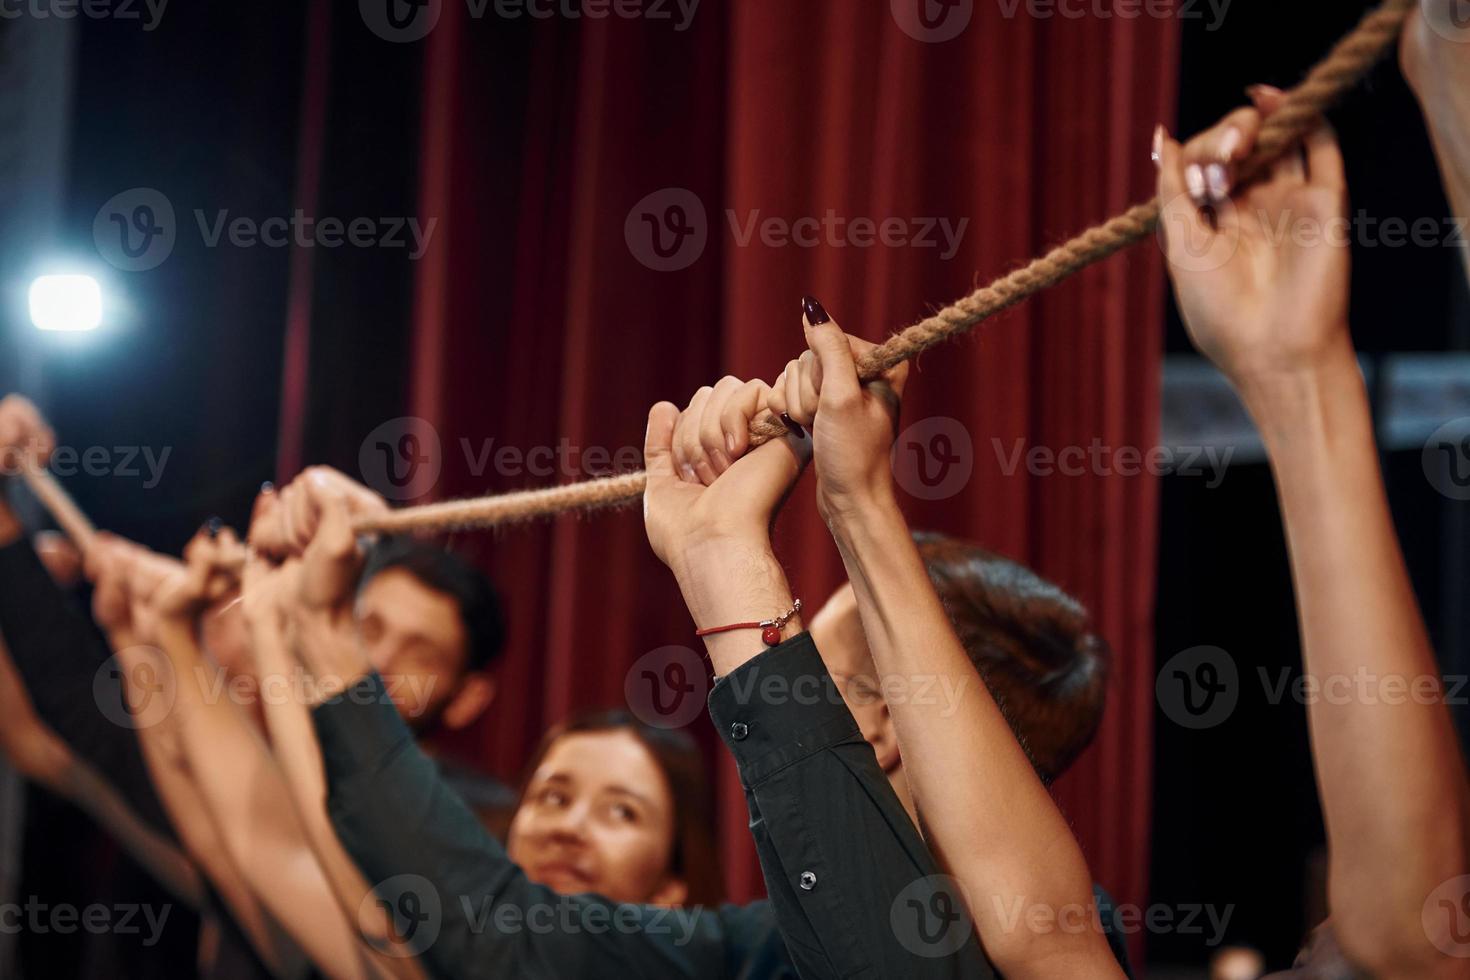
[1157,90,1470,979]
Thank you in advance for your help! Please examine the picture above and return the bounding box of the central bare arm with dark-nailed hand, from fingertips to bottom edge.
[772,315,1122,979]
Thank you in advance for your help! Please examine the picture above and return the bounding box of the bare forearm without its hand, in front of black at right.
[1242,350,1467,965]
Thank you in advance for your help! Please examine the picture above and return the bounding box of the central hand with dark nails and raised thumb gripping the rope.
[769,298,908,525]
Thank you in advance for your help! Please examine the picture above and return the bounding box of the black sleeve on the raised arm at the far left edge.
[0,538,176,840]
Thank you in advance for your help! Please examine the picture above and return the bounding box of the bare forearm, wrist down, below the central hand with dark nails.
[832,498,1117,977]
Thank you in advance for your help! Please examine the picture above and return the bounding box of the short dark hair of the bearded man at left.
[357,536,506,670]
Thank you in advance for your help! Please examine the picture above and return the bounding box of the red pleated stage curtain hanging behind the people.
[391,0,1177,957]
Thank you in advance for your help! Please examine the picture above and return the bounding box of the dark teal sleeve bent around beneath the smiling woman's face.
[312,674,789,980]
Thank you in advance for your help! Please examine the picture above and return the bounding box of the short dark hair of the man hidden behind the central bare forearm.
[914,532,1113,783]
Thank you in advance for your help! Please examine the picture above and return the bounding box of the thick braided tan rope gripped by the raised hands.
[356,0,1417,532]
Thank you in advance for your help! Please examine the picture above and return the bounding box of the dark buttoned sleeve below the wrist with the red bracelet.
[710,633,995,980]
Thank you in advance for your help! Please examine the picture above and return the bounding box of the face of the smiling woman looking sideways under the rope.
[506,730,688,905]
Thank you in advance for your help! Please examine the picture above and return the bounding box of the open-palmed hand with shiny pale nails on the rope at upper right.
[1154,87,1352,389]
